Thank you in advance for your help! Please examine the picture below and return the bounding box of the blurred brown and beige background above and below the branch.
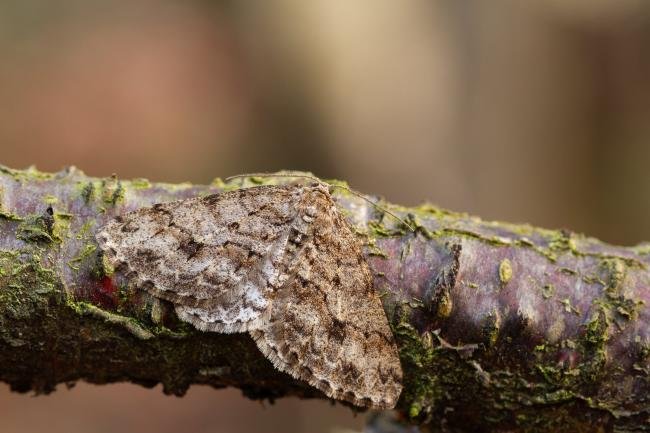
[0,0,650,433]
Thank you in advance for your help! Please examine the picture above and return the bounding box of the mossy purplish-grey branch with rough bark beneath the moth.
[0,164,650,432]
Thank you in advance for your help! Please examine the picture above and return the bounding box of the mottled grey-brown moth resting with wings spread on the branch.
[97,182,402,409]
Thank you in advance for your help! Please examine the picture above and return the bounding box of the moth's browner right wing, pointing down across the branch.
[251,188,402,409]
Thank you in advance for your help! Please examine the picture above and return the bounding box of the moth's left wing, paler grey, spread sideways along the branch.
[97,186,300,332]
